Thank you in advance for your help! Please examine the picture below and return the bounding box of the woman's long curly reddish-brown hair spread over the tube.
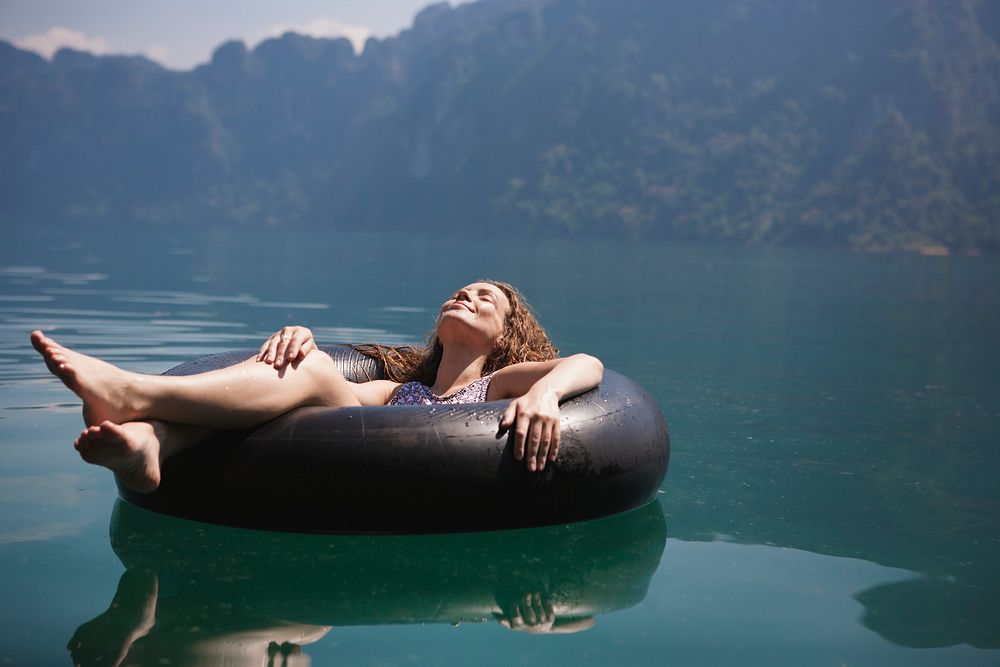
[351,280,559,386]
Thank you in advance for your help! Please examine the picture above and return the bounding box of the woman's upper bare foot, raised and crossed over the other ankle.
[31,331,141,426]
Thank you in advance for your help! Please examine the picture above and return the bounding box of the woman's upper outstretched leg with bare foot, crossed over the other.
[31,331,360,429]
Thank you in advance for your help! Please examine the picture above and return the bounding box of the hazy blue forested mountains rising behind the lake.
[0,0,1000,252]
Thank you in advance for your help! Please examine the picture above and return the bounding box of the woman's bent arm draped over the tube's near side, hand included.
[486,354,604,470]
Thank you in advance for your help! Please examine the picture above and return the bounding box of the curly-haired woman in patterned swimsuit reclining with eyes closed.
[31,281,604,493]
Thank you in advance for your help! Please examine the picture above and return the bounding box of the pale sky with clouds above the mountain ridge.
[0,0,446,70]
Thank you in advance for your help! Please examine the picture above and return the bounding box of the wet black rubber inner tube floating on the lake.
[118,346,670,533]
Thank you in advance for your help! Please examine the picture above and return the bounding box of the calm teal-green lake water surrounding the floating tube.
[0,229,1000,665]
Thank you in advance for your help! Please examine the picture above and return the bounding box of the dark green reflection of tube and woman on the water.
[69,500,666,665]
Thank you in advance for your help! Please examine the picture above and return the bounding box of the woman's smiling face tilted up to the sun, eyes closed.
[437,283,510,348]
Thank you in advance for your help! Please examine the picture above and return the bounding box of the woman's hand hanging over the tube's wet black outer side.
[500,387,560,470]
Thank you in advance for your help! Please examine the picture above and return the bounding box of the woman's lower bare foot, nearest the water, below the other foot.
[73,421,165,493]
